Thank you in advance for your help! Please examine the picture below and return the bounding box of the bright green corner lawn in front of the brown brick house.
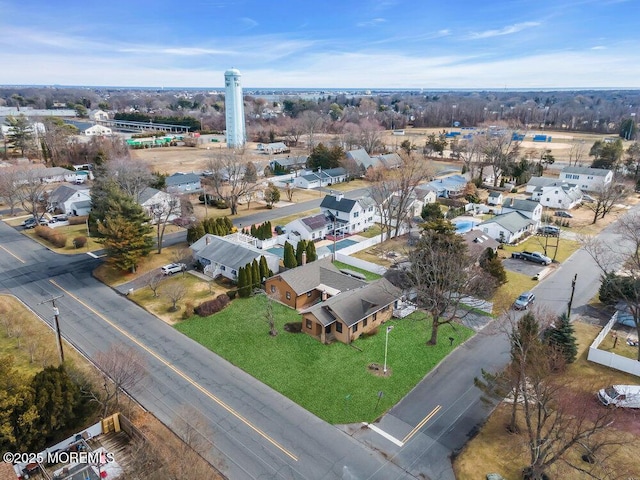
[175,296,473,424]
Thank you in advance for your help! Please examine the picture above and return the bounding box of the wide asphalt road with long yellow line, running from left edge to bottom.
[0,222,411,480]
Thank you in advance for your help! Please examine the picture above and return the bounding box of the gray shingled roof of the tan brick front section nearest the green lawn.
[302,278,402,327]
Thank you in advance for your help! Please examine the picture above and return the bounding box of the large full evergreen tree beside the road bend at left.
[98,188,153,272]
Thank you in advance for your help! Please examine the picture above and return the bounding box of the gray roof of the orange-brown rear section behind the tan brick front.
[278,257,366,295]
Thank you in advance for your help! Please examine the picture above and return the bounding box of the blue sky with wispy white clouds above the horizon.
[0,0,640,89]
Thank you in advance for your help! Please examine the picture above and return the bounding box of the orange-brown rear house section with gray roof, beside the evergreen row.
[265,257,366,309]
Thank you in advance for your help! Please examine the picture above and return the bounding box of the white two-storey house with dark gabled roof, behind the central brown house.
[320,193,375,235]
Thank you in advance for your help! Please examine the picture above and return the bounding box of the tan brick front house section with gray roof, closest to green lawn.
[301,278,402,344]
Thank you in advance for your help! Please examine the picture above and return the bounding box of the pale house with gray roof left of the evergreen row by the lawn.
[190,233,280,281]
